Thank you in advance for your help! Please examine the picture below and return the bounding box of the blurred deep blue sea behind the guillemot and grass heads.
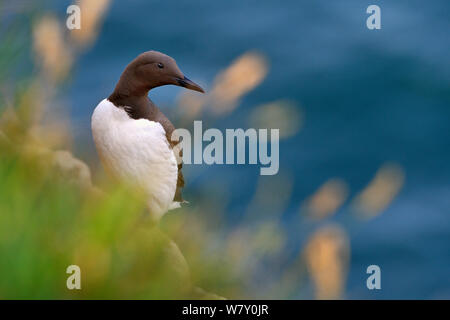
[57,0,450,299]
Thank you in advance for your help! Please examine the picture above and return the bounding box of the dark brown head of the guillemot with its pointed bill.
[115,51,205,94]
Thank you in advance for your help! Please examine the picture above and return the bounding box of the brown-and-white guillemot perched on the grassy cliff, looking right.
[91,51,204,219]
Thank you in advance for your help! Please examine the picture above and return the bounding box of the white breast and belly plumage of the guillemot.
[91,99,178,218]
